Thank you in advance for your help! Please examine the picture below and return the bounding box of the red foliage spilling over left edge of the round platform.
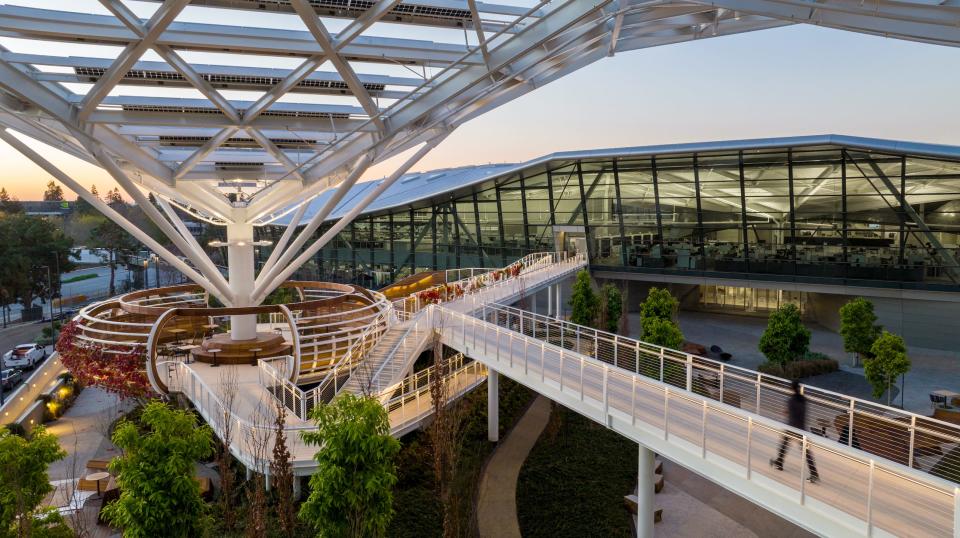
[56,321,153,399]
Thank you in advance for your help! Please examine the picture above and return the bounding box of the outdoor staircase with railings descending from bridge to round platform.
[337,315,433,399]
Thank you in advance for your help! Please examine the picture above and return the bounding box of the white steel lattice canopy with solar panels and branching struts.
[0,0,960,312]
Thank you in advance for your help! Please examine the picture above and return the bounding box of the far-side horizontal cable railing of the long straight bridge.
[477,305,960,483]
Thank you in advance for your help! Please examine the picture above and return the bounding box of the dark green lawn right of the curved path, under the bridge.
[517,406,637,538]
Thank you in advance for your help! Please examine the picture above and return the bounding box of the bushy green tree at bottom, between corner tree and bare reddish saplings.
[104,402,213,538]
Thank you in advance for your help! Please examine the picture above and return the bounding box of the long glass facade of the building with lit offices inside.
[264,137,960,290]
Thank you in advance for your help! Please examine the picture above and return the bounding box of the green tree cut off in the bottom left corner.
[0,426,73,538]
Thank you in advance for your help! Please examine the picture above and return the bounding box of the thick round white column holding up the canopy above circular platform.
[227,223,257,340]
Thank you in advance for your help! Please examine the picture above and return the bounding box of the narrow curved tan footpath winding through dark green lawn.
[477,396,550,538]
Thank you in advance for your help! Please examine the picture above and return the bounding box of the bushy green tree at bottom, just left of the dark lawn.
[300,394,400,538]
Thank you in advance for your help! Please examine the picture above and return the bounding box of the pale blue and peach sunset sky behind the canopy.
[0,0,960,200]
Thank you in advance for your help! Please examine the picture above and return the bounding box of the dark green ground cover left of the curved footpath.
[387,376,540,538]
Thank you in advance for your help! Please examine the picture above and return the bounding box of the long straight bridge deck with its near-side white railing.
[435,306,960,536]
